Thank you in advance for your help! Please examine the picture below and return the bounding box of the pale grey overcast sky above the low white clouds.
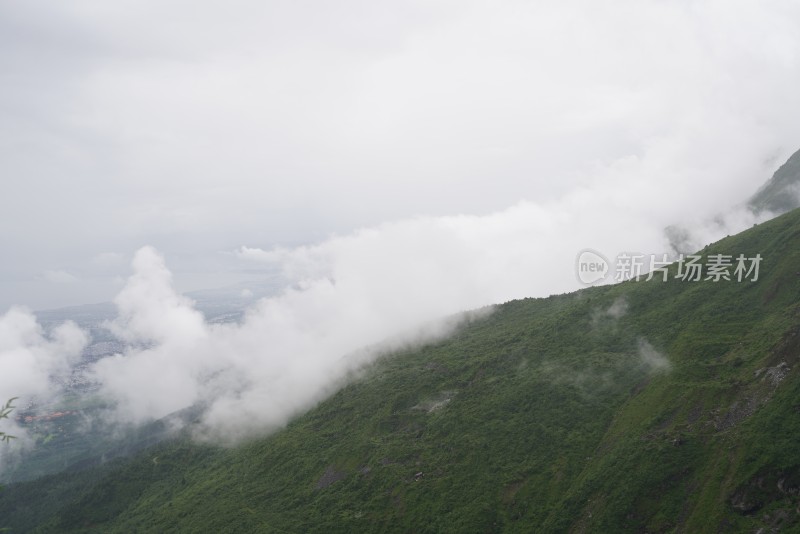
[0,0,800,311]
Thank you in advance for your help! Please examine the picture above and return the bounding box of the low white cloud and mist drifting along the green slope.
[0,190,780,460]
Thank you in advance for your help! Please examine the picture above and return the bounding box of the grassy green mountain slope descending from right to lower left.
[0,211,800,533]
